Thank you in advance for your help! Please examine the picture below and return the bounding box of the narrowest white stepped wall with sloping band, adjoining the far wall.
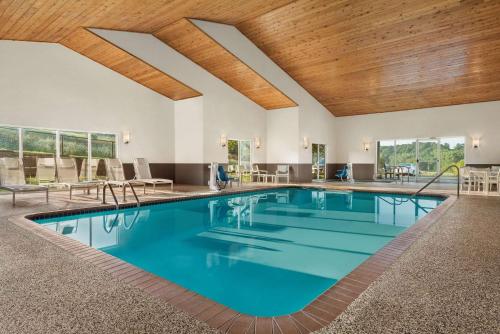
[192,20,335,163]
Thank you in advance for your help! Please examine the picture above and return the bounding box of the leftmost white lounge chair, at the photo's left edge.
[0,158,49,206]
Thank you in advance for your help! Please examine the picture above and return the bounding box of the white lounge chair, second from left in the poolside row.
[56,158,101,199]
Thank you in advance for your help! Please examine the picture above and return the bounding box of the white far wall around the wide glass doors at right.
[335,101,500,164]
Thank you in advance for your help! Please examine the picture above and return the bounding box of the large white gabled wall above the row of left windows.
[0,40,174,162]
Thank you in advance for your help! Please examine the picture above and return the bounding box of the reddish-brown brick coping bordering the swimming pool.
[9,185,457,333]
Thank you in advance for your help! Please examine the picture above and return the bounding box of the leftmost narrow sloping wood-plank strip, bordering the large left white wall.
[60,28,201,100]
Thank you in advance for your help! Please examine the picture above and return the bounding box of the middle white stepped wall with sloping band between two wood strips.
[93,29,267,163]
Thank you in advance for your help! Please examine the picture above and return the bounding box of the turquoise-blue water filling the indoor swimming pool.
[38,188,442,316]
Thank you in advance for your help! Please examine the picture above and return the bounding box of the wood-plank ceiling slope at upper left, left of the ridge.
[0,0,291,42]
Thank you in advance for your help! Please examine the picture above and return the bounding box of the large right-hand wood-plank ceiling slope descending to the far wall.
[238,0,500,116]
